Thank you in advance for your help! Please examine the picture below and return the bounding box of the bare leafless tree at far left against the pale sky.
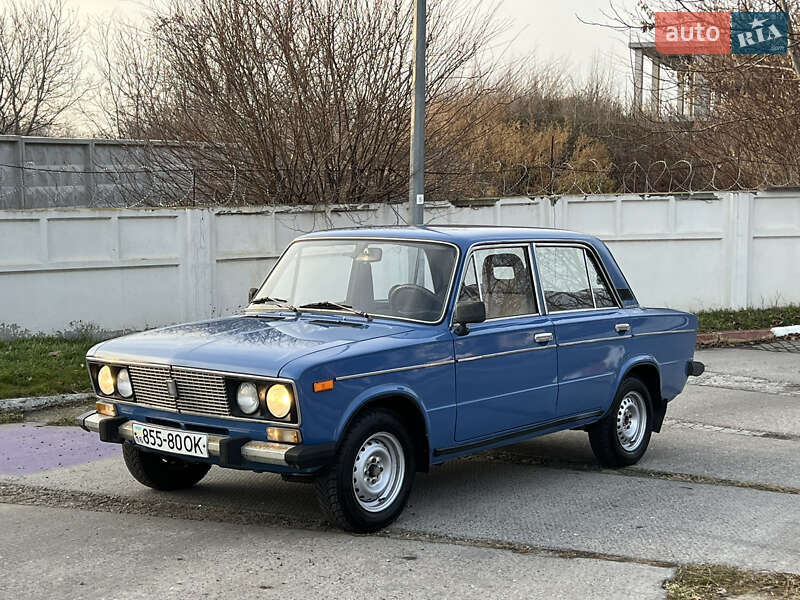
[0,0,85,135]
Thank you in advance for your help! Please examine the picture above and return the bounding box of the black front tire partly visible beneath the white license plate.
[122,444,211,491]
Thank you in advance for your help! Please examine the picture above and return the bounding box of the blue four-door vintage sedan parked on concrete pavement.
[79,226,703,532]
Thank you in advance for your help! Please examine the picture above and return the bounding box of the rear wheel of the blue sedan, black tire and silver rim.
[589,377,653,467]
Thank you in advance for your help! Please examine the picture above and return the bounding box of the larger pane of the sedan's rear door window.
[536,246,594,312]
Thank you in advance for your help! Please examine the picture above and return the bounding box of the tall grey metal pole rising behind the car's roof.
[408,0,426,225]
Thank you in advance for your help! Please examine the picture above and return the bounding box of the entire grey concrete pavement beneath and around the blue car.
[0,349,800,598]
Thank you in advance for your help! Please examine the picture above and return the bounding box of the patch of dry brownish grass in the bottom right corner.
[664,565,800,600]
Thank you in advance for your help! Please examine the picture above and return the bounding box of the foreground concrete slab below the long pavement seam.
[0,505,672,600]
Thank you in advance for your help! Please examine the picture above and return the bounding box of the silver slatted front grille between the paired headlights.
[128,365,231,417]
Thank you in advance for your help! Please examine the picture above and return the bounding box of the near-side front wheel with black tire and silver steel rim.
[314,409,416,533]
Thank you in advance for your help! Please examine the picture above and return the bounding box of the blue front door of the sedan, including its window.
[454,244,558,441]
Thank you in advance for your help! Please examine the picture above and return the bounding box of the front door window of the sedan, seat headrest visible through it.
[458,247,538,319]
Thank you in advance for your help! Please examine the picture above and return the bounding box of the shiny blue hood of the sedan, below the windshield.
[89,315,411,377]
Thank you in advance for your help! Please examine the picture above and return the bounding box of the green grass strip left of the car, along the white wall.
[0,336,97,398]
